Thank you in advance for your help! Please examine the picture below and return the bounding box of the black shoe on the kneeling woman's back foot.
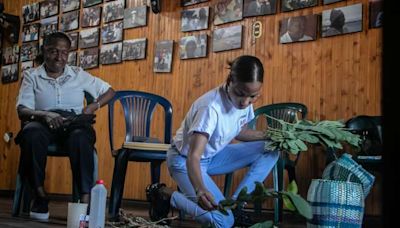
[146,183,171,225]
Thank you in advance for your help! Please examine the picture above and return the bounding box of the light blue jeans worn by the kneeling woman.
[167,141,279,227]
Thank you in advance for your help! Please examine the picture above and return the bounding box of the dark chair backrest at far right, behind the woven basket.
[346,115,383,155]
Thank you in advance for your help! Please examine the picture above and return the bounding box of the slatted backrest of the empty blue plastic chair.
[108,90,172,151]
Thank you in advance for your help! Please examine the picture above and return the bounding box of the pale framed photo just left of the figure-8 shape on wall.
[213,25,243,52]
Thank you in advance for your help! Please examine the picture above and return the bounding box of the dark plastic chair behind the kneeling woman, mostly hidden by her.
[224,103,308,224]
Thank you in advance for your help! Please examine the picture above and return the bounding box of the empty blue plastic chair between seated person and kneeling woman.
[108,91,172,219]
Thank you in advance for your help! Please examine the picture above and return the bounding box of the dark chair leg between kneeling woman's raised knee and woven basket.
[273,156,285,225]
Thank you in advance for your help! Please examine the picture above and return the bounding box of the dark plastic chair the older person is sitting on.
[11,92,98,216]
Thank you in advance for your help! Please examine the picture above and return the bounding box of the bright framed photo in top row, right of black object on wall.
[181,7,210,32]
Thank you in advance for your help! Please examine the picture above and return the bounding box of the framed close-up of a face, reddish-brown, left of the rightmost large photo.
[279,15,318,44]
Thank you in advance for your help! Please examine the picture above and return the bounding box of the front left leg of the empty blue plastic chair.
[108,150,128,219]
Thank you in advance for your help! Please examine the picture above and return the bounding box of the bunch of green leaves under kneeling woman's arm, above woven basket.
[265,115,361,154]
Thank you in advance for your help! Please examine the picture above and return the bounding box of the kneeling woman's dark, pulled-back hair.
[227,55,264,85]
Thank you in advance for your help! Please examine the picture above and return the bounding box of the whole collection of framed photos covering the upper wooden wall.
[1,0,383,83]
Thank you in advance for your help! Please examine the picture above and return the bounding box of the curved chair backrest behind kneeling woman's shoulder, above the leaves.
[249,102,308,128]
